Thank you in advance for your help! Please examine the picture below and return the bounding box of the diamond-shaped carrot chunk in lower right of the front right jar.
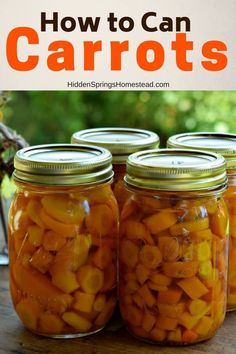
[177,277,209,300]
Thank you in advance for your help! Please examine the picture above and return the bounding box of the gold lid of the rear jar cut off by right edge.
[167,132,236,169]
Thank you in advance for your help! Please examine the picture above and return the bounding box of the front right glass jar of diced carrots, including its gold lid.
[119,149,228,345]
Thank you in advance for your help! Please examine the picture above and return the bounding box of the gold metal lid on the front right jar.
[125,149,227,191]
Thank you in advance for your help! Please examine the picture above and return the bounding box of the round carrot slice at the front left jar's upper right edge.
[85,204,115,236]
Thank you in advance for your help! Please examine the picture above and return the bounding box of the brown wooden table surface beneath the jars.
[0,267,236,354]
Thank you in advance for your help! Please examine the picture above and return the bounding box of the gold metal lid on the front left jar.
[13,144,113,186]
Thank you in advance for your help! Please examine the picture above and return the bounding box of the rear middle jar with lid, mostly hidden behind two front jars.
[71,128,159,210]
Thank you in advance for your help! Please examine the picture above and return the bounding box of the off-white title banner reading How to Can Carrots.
[0,0,236,90]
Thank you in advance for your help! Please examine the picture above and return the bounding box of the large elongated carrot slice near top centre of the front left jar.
[41,195,85,225]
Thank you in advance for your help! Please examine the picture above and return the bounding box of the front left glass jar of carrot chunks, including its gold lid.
[9,144,118,338]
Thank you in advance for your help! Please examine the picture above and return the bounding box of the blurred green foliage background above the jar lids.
[4,91,236,146]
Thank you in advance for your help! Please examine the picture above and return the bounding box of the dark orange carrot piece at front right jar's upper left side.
[125,220,154,245]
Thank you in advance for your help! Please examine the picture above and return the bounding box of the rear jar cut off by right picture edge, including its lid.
[167,133,236,311]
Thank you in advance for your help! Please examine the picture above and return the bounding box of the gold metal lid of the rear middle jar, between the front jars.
[71,128,160,164]
